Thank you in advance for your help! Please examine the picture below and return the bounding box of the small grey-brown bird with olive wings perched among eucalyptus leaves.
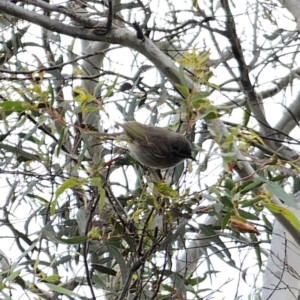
[117,121,195,169]
